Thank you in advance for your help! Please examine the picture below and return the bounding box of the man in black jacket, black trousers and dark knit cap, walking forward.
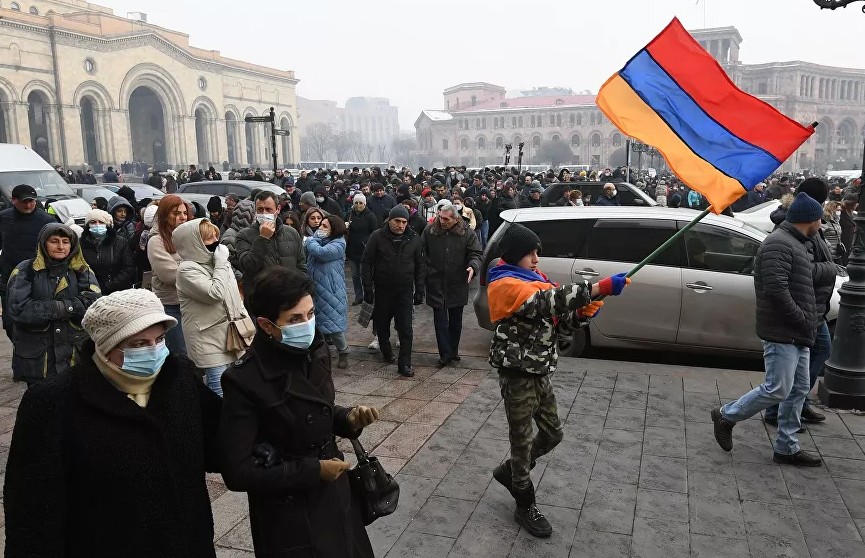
[361,205,426,378]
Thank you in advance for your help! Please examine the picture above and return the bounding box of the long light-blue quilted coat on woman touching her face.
[305,237,348,333]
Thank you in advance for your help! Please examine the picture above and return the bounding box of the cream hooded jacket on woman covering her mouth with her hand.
[171,219,248,368]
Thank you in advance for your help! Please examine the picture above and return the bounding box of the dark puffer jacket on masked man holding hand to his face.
[230,219,306,283]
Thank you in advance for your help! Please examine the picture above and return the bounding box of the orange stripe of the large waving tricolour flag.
[597,74,745,213]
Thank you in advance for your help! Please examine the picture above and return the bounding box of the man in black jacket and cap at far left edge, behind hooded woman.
[0,184,57,340]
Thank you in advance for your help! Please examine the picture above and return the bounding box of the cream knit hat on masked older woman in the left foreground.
[81,289,177,356]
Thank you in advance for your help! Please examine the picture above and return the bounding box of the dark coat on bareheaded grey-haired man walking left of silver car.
[421,220,483,308]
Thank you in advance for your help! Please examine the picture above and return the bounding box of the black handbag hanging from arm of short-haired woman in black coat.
[347,438,399,525]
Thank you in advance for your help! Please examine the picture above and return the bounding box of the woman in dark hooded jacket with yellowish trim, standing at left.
[6,223,101,385]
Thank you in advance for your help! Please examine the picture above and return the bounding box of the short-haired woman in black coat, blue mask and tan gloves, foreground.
[220,267,378,558]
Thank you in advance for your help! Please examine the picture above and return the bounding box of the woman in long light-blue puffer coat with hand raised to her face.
[304,215,348,368]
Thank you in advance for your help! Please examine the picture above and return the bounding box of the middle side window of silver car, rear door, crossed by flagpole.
[585,219,684,267]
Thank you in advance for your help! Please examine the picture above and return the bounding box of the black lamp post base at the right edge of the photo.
[818,136,865,411]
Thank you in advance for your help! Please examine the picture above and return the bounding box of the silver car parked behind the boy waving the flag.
[474,207,846,358]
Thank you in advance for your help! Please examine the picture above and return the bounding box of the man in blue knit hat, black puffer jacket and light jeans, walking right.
[712,192,823,467]
